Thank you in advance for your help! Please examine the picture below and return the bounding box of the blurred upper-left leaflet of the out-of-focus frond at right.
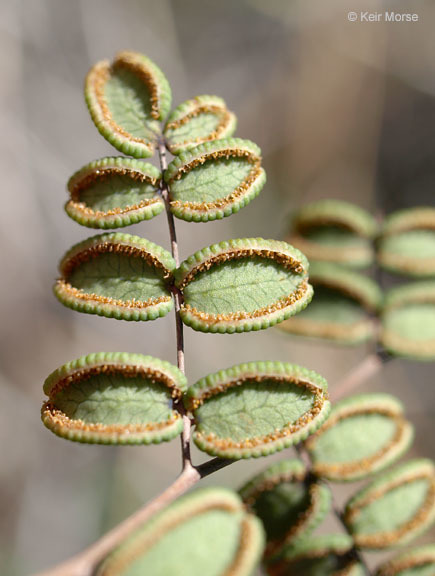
[289,199,377,268]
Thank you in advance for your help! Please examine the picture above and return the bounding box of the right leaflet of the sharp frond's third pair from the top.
[176,238,312,333]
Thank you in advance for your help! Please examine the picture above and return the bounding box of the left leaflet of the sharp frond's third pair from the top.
[54,233,175,320]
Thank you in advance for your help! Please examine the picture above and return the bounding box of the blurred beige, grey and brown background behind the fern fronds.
[0,0,435,576]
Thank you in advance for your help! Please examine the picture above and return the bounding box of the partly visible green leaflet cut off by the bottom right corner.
[376,544,435,576]
